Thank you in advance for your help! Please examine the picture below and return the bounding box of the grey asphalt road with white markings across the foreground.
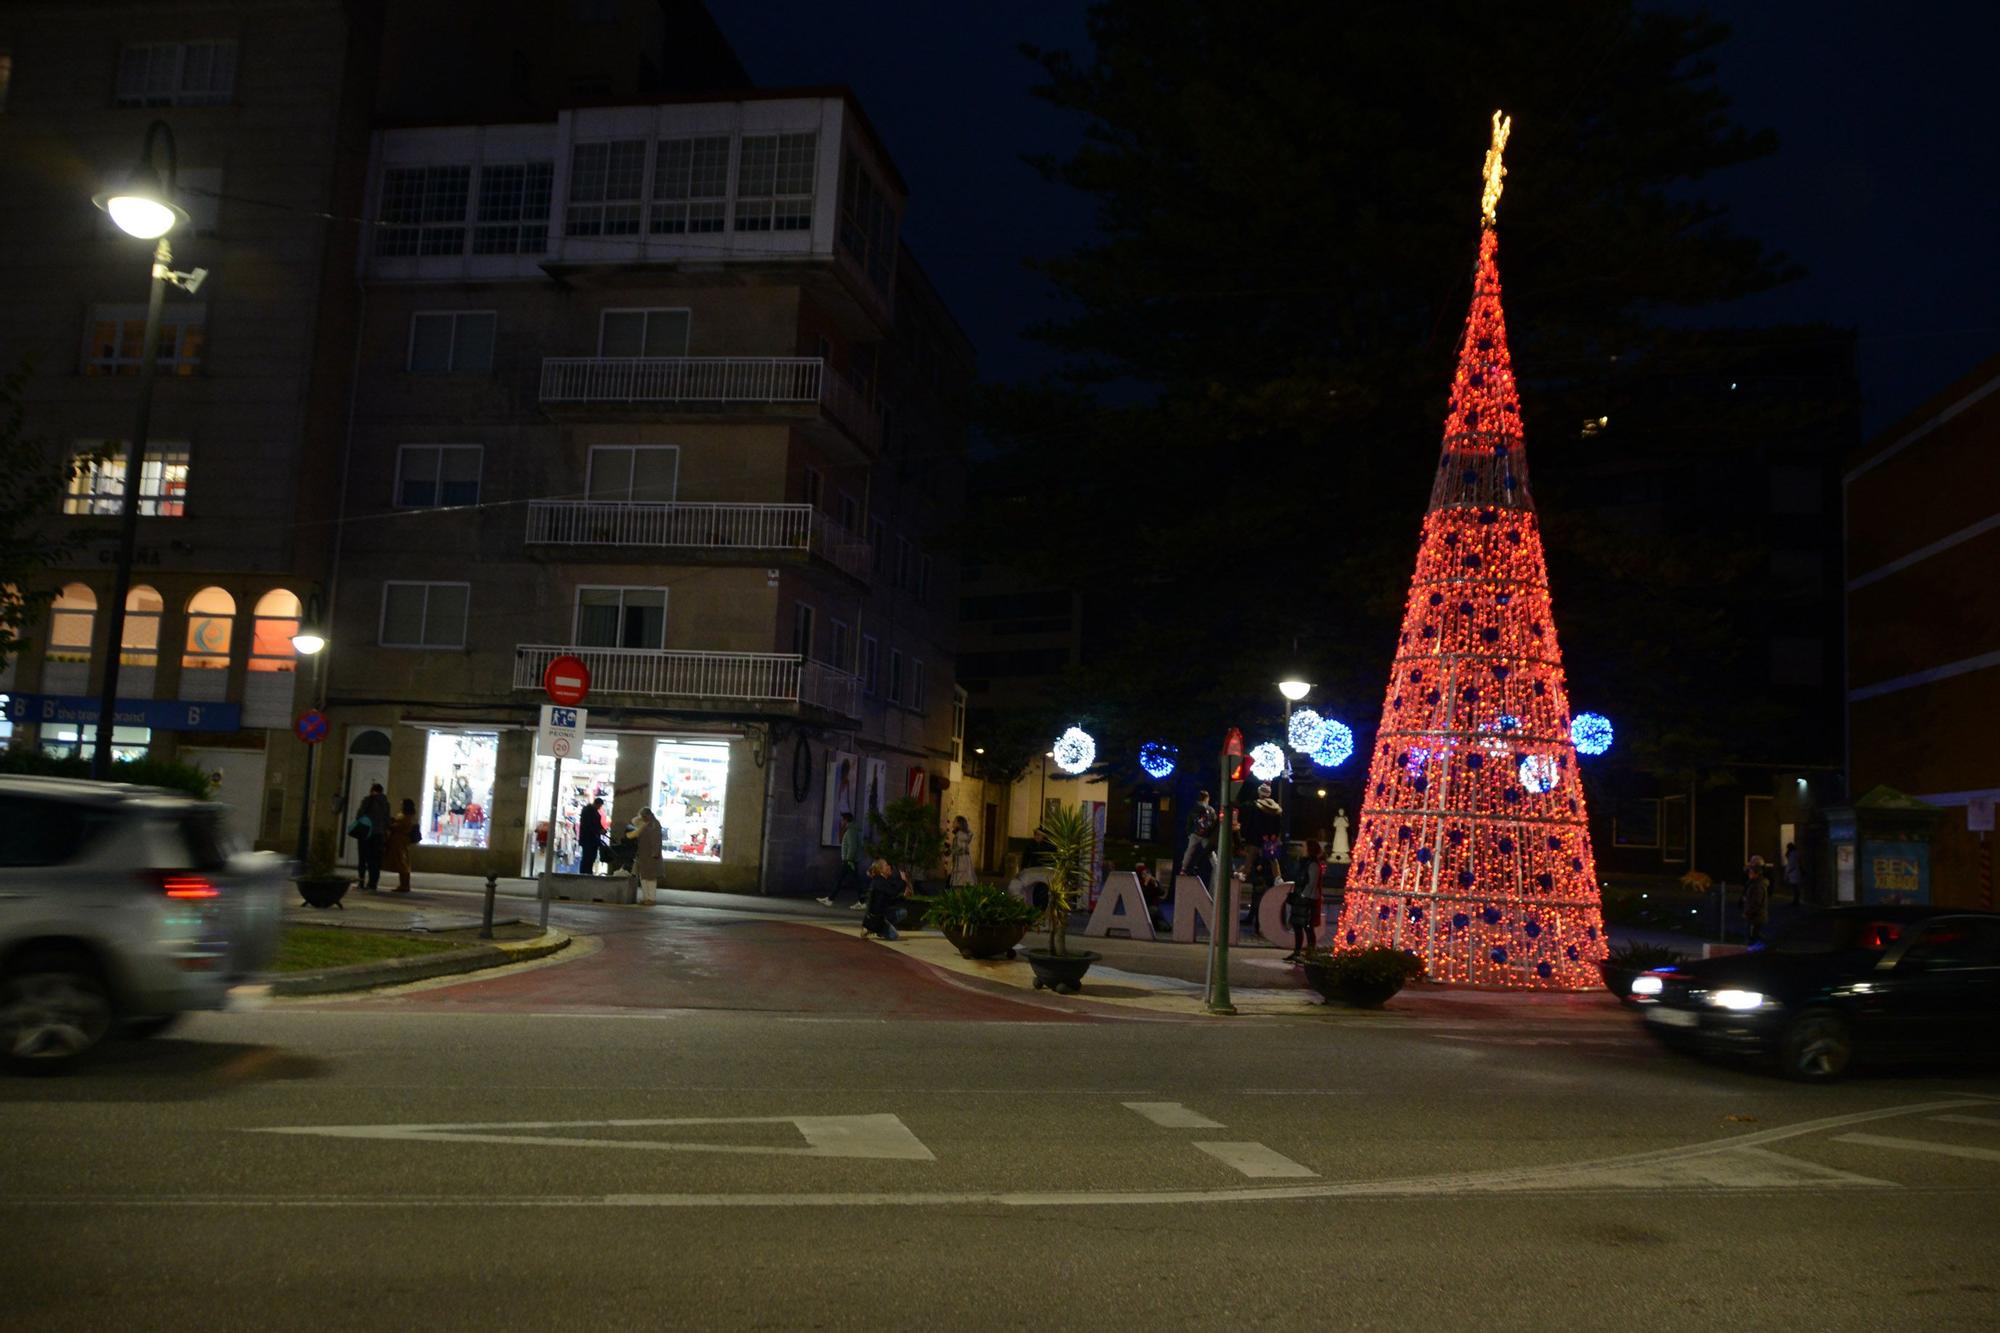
[0,907,2000,1329]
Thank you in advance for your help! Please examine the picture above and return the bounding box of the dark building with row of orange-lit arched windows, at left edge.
[0,0,378,847]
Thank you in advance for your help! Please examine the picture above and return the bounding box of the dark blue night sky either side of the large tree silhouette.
[710,0,2000,432]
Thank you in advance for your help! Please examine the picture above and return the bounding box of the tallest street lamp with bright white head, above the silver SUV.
[90,120,208,779]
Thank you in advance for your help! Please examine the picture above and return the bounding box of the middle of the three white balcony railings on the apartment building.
[528,500,874,578]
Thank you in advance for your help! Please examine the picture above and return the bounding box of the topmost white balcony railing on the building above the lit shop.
[542,356,882,448]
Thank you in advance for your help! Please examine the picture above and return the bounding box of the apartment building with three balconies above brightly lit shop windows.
[328,90,972,893]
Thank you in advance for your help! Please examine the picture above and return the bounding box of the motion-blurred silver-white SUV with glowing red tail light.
[0,777,288,1067]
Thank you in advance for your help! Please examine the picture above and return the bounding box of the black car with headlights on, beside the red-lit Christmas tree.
[1632,907,2000,1079]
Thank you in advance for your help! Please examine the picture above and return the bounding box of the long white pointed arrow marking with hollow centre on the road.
[248,1115,936,1161]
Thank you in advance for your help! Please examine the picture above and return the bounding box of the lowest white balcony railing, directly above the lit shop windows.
[514,644,860,717]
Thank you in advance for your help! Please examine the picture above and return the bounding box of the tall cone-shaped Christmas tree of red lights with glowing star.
[1334,112,1604,991]
